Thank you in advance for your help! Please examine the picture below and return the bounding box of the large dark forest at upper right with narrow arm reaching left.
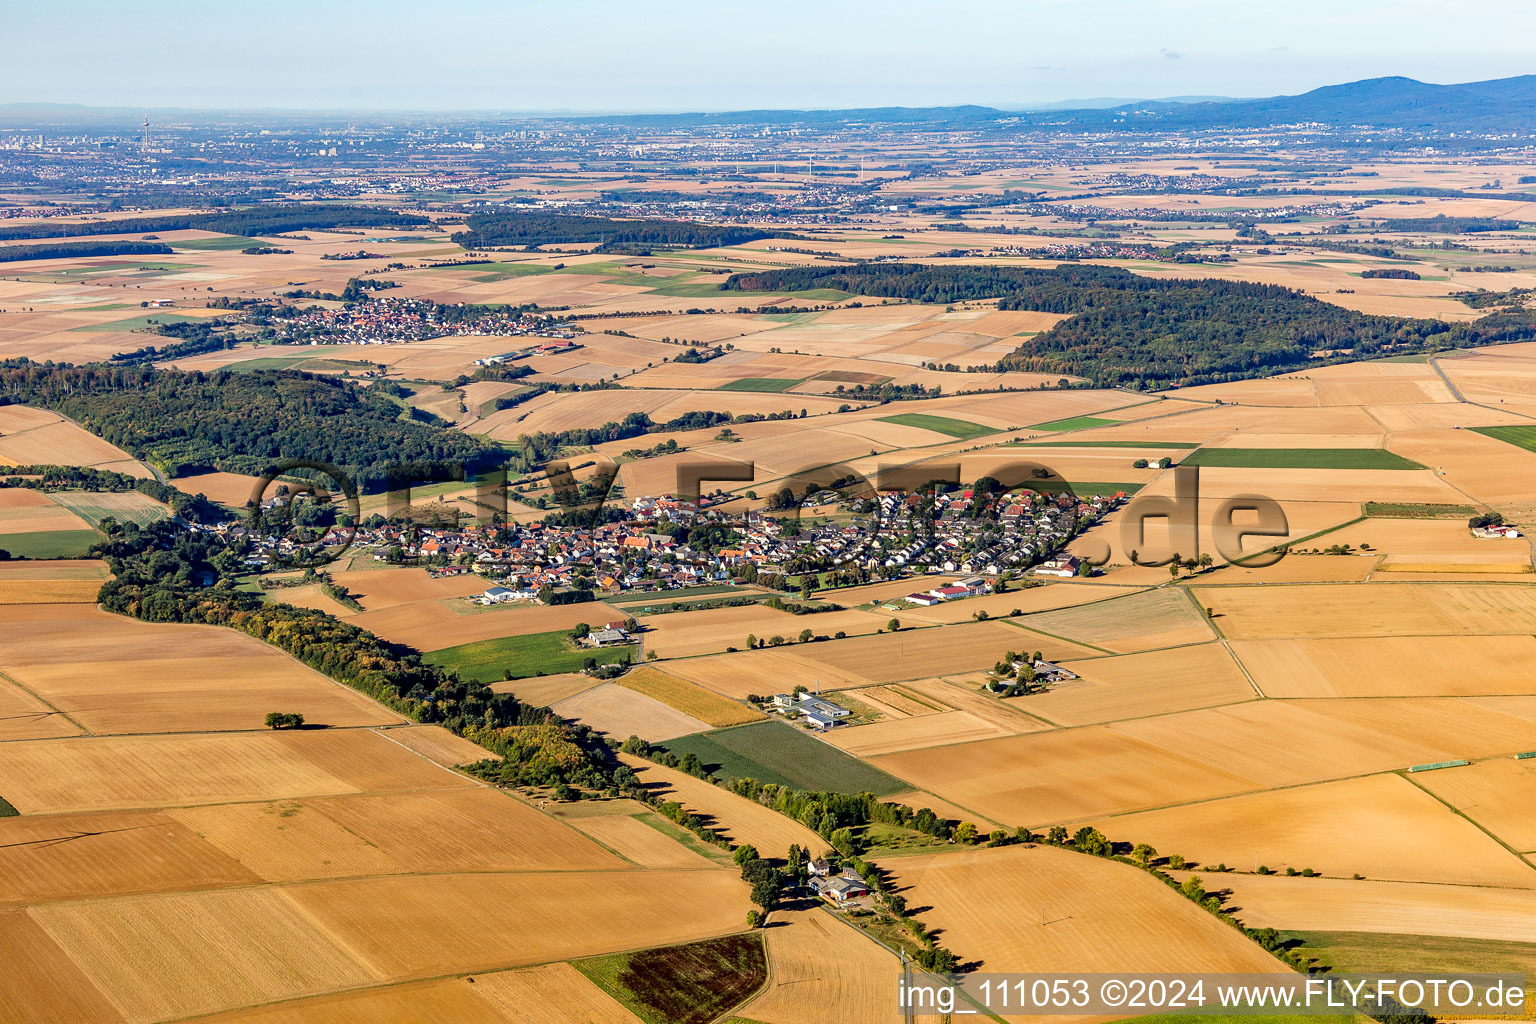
[722,264,1536,387]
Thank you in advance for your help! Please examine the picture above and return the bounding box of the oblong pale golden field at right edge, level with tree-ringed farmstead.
[1218,635,1536,697]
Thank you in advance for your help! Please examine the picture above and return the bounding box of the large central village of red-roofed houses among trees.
[216,490,1124,606]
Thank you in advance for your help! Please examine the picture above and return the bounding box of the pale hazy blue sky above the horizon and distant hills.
[12,0,1536,111]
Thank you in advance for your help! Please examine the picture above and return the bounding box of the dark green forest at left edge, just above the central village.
[0,359,496,491]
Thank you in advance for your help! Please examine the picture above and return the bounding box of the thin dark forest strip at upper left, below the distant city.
[0,203,432,239]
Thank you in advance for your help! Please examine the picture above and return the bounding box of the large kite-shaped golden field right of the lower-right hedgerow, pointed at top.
[1094,773,1536,889]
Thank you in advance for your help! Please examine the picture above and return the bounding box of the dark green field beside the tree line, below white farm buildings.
[662,722,909,797]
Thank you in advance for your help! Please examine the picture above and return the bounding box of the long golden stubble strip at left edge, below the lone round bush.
[0,729,472,814]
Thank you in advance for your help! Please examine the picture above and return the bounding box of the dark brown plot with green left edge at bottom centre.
[571,930,768,1024]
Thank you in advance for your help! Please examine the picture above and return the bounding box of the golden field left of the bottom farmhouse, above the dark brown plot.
[284,867,748,978]
